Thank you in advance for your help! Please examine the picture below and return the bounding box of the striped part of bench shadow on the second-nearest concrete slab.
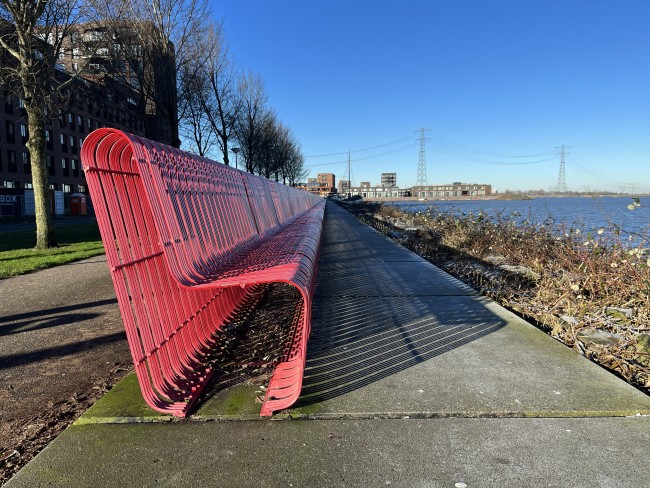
[296,297,506,407]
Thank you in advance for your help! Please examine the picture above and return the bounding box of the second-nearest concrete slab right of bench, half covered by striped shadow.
[290,296,650,418]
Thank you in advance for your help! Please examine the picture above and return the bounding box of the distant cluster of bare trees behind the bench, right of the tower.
[179,24,305,185]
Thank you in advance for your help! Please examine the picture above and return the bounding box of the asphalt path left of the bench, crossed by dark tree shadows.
[0,256,132,478]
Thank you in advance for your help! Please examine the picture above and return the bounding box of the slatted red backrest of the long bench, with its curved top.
[84,129,321,285]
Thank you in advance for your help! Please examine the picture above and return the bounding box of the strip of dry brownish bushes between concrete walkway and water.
[346,201,650,393]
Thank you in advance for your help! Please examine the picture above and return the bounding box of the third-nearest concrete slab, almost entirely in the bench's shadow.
[316,262,478,297]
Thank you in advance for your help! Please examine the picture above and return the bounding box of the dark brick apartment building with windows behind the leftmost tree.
[0,22,178,218]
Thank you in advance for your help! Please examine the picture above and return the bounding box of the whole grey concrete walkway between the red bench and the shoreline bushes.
[7,204,650,488]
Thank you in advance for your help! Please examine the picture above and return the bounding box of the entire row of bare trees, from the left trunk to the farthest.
[0,0,302,248]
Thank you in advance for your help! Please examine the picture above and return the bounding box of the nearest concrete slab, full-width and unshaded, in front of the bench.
[6,417,650,488]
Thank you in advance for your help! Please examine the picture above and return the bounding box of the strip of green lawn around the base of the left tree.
[0,223,104,278]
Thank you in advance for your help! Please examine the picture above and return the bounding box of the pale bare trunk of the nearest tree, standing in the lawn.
[26,106,58,249]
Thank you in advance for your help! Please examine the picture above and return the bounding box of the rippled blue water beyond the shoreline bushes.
[392,197,650,243]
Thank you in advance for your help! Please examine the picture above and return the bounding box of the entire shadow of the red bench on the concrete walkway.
[296,205,506,407]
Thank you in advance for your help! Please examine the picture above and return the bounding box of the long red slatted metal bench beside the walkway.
[81,129,325,416]
